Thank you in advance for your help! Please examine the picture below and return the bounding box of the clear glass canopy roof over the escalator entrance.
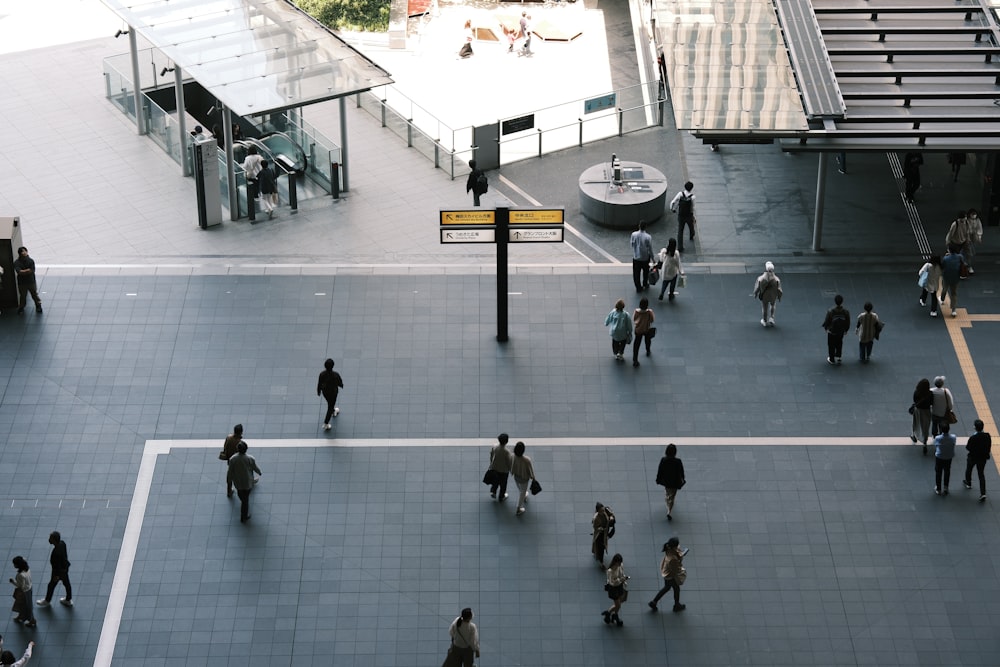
[102,0,392,116]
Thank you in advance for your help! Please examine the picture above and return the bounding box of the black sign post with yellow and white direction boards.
[439,206,566,343]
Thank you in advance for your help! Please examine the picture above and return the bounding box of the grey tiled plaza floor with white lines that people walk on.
[0,0,1000,667]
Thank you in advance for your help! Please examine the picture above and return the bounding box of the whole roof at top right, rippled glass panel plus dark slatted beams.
[655,0,1000,152]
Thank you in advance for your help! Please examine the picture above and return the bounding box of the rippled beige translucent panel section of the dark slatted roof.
[656,0,808,132]
